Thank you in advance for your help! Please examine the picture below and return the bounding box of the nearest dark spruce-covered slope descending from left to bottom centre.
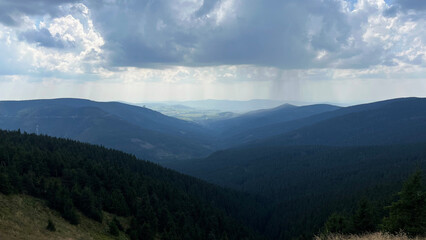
[0,131,266,239]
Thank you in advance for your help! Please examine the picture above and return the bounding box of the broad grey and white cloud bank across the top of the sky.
[0,0,426,79]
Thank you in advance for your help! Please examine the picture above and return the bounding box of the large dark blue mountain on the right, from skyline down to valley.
[168,98,426,239]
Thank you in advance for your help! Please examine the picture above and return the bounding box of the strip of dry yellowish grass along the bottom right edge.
[315,233,426,240]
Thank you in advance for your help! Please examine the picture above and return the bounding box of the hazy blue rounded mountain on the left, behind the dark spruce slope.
[0,99,212,161]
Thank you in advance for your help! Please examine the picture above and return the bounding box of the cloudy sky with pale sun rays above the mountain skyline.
[0,0,426,103]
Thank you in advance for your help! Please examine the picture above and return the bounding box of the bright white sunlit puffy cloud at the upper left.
[0,1,104,76]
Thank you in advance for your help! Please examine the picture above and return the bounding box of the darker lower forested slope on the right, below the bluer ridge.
[171,144,426,239]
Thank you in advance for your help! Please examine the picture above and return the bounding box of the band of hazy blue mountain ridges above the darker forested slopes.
[0,98,426,162]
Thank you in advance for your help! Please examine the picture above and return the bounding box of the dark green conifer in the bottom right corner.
[383,171,426,236]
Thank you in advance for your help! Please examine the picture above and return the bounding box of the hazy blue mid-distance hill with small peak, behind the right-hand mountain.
[208,104,340,147]
